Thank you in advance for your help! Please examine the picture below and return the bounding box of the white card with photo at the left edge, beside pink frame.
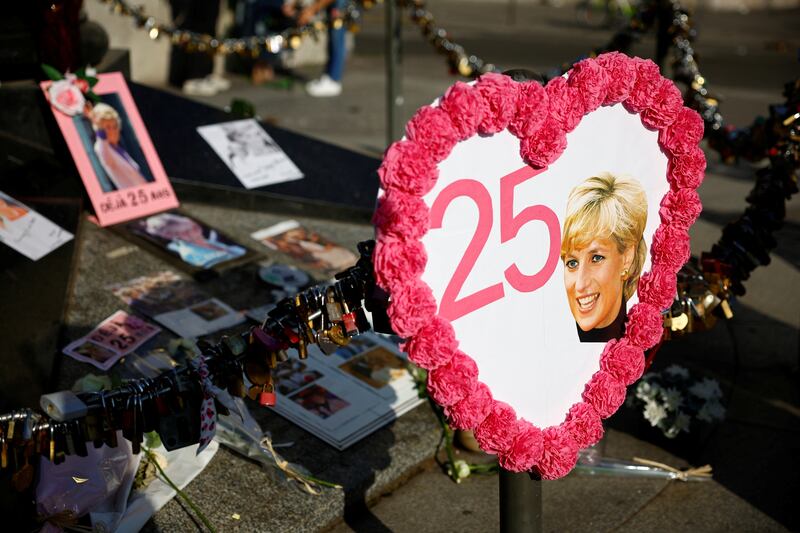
[0,191,73,261]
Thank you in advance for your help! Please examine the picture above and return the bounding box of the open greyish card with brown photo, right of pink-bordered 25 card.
[108,271,245,338]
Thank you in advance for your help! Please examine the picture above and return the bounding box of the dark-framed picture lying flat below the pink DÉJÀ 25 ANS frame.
[113,211,257,279]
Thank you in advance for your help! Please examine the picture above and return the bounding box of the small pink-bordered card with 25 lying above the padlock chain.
[63,311,161,370]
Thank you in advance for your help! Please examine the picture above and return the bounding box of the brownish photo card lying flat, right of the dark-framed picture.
[251,220,358,278]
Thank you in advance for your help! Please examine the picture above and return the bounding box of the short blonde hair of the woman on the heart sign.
[561,172,647,301]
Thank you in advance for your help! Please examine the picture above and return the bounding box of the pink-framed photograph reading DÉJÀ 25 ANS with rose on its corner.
[41,72,178,226]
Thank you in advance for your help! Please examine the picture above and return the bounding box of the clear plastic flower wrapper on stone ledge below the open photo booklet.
[215,393,341,494]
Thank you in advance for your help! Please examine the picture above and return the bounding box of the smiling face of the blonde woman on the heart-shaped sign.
[564,237,633,331]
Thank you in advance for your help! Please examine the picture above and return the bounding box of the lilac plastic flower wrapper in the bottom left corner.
[36,432,141,533]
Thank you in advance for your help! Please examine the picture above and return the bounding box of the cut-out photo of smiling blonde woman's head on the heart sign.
[561,172,647,342]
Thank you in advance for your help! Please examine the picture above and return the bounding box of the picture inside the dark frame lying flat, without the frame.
[125,212,247,268]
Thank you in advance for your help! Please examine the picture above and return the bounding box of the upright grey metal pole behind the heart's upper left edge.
[386,0,403,146]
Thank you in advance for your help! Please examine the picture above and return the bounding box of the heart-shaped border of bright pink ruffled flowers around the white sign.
[373,52,706,479]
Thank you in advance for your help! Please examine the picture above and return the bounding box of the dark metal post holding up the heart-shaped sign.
[500,468,542,533]
